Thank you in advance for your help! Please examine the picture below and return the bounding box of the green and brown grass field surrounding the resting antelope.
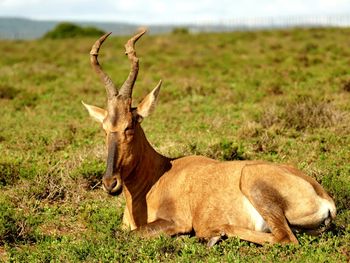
[0,28,350,262]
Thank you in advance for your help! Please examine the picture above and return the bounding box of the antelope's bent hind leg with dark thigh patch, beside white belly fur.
[241,175,299,244]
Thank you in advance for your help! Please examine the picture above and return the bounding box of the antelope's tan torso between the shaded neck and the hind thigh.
[148,156,266,232]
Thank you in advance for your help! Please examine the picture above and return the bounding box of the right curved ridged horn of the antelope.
[119,29,146,98]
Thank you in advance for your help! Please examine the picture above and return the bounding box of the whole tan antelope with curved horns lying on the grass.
[83,31,336,248]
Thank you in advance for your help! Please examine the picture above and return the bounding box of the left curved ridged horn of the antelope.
[90,32,118,100]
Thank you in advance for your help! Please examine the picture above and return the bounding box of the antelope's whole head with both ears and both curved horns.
[83,30,162,195]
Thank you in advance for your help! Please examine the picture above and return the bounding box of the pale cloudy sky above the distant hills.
[0,0,350,24]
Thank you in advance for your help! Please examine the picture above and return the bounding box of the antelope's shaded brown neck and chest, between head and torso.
[124,129,171,226]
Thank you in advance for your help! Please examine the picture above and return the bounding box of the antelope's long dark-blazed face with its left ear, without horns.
[84,96,142,195]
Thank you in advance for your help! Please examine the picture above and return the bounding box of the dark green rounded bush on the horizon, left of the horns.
[44,22,105,39]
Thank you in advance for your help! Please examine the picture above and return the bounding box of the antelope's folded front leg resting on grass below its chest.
[133,219,183,237]
